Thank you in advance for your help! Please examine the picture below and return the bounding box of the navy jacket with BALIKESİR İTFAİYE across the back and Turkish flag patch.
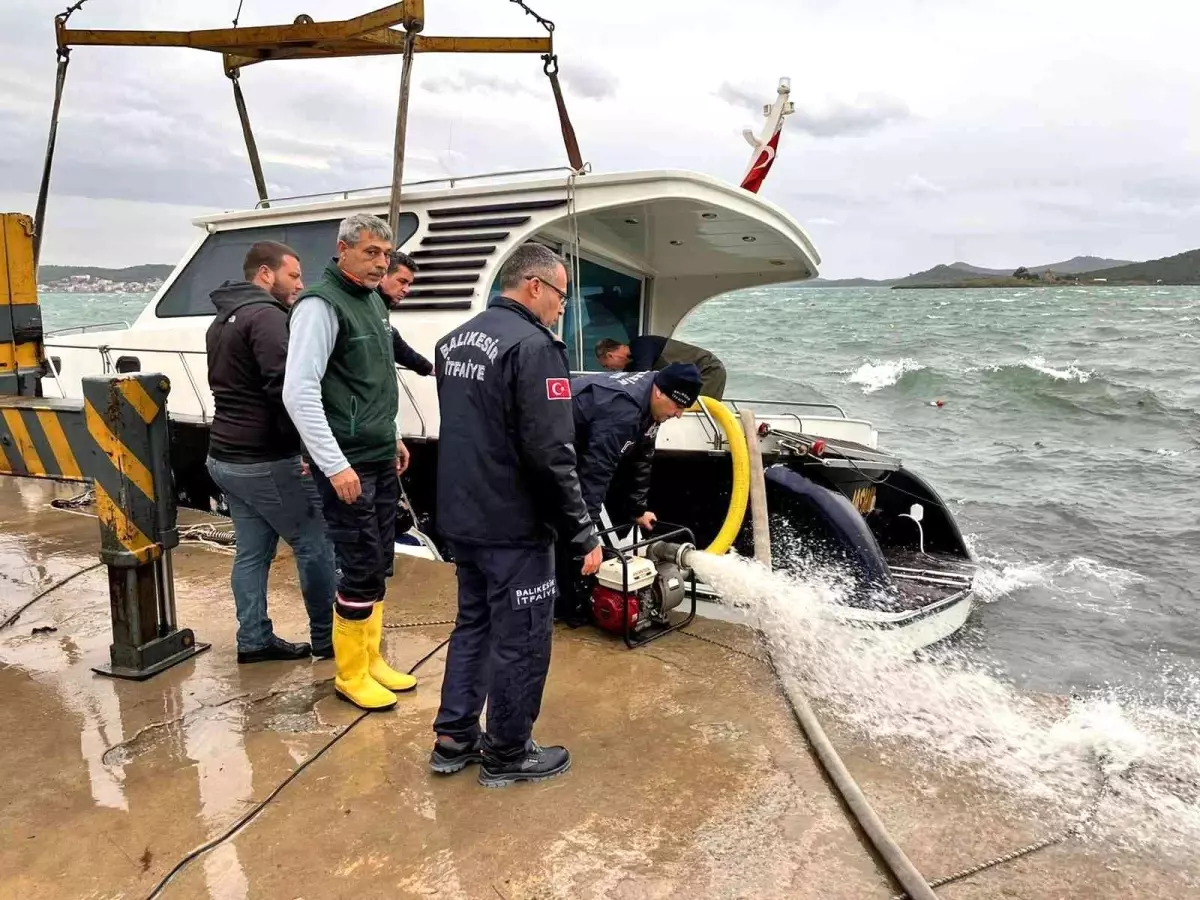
[434,296,600,552]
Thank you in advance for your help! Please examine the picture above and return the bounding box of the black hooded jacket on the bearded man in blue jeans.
[204,281,300,463]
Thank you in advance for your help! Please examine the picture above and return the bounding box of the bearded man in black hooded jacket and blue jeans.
[205,241,336,662]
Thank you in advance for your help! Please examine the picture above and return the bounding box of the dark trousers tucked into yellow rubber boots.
[312,460,400,619]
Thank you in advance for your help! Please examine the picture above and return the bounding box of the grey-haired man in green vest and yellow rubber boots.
[283,214,416,709]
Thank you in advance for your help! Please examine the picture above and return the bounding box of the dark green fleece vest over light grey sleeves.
[296,262,400,466]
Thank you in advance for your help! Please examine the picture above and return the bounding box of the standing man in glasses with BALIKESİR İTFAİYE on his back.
[430,244,600,787]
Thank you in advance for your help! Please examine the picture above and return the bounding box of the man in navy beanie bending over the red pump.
[556,362,701,623]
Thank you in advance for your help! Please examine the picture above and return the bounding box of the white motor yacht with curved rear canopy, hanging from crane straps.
[43,160,971,646]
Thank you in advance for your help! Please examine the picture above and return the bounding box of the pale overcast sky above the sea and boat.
[0,0,1200,277]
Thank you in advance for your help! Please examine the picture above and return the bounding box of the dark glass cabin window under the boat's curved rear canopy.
[488,247,646,372]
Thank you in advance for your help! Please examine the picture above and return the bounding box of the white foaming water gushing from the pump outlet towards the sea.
[692,553,1200,852]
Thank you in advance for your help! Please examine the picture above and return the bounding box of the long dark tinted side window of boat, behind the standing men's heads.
[155,212,418,319]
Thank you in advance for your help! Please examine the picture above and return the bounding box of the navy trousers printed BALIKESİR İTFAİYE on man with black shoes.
[433,544,557,761]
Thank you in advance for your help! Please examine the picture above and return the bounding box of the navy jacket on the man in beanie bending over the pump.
[571,372,659,523]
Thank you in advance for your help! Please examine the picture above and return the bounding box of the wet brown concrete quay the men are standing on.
[0,479,1200,900]
